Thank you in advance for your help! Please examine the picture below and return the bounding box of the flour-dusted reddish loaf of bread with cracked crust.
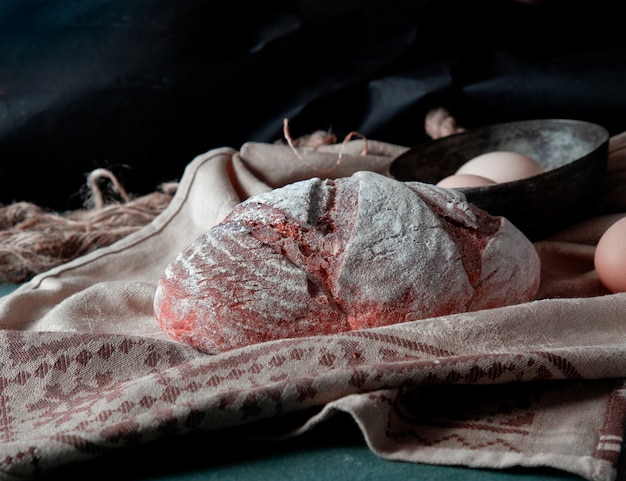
[154,172,540,353]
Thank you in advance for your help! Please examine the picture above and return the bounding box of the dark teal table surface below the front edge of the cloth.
[37,408,582,481]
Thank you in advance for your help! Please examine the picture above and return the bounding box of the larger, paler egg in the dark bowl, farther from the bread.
[456,151,545,184]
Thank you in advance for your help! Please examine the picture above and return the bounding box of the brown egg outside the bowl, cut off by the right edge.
[594,217,626,292]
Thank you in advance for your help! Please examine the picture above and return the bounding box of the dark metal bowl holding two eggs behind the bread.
[389,119,609,240]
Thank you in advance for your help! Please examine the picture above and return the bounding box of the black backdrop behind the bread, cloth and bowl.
[0,0,626,210]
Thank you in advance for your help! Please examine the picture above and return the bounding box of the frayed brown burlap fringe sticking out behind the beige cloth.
[0,107,463,284]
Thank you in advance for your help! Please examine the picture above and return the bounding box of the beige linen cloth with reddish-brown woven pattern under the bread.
[0,137,626,481]
